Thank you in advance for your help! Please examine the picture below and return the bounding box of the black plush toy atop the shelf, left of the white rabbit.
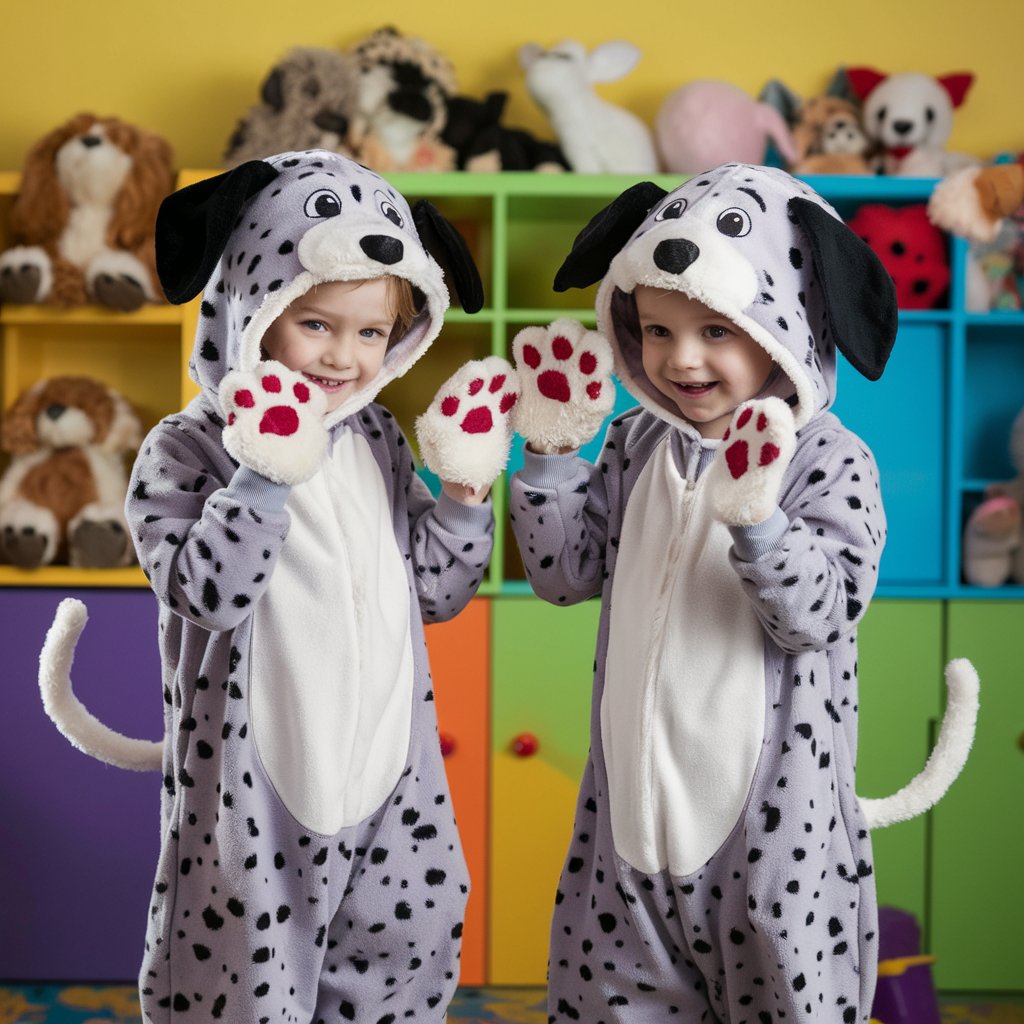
[441,92,569,172]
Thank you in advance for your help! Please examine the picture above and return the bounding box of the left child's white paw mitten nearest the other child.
[416,355,519,490]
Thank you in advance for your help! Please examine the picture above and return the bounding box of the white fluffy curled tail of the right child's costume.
[860,657,979,828]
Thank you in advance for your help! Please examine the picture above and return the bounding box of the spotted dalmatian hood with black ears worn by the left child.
[157,150,483,426]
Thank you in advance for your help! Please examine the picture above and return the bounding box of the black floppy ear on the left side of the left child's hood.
[157,160,279,304]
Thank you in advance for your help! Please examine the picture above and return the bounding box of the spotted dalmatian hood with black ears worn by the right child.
[555,164,897,429]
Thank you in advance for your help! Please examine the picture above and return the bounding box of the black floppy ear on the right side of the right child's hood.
[788,198,898,381]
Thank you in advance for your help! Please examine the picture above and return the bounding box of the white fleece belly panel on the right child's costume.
[601,438,765,876]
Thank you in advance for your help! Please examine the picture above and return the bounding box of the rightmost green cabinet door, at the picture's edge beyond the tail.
[931,601,1024,991]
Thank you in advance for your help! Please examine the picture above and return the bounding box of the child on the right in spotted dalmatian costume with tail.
[512,165,977,1024]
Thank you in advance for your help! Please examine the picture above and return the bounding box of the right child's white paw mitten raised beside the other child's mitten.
[512,319,615,453]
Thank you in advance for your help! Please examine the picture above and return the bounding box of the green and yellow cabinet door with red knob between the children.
[487,597,601,985]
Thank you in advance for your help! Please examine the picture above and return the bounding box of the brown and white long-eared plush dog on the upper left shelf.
[0,114,174,311]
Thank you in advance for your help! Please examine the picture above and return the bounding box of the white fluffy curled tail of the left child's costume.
[39,597,163,771]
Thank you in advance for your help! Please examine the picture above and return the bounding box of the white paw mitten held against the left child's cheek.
[220,359,328,485]
